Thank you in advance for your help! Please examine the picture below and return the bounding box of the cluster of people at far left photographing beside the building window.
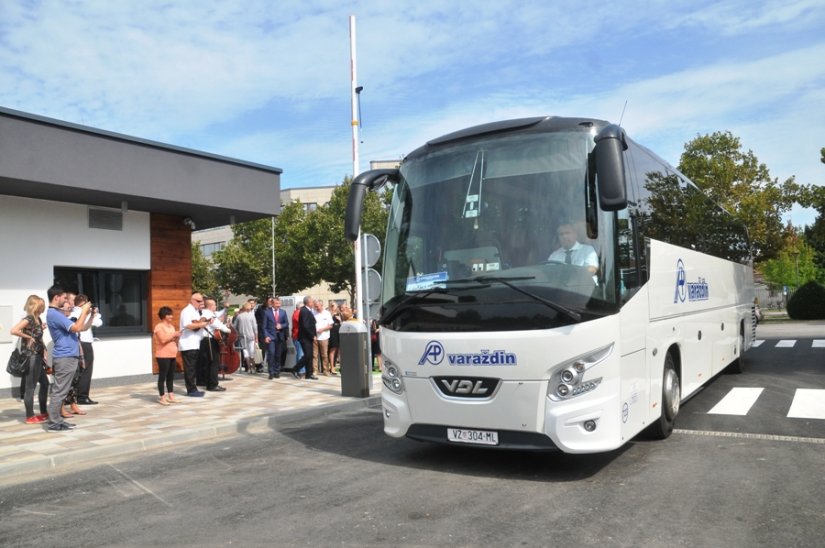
[11,285,102,432]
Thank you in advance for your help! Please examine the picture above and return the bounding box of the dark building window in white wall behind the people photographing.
[54,267,148,337]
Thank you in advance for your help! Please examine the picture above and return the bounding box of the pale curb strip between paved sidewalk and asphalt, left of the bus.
[0,394,381,485]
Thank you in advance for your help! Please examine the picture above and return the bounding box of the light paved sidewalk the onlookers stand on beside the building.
[0,372,381,483]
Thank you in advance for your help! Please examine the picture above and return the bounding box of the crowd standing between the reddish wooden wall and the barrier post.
[153,292,352,405]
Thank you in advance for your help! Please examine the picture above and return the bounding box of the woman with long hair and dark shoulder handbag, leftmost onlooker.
[11,295,49,424]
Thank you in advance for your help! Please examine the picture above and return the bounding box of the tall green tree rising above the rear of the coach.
[679,131,800,261]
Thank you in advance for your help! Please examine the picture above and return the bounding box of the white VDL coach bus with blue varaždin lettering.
[345,117,755,453]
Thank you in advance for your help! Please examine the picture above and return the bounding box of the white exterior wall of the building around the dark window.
[0,195,152,389]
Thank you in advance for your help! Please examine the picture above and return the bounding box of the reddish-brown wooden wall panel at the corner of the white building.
[148,213,192,374]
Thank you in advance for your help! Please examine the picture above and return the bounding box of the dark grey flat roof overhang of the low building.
[0,107,282,229]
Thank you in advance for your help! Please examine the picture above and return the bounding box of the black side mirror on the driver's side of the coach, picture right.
[594,124,627,211]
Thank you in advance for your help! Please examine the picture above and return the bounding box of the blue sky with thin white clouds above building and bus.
[0,0,825,224]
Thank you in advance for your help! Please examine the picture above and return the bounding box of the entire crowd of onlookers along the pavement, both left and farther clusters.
[11,285,374,432]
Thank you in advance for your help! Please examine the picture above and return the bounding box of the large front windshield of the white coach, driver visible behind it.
[381,130,618,332]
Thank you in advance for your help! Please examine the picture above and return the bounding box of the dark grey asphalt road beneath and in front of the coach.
[0,324,825,547]
